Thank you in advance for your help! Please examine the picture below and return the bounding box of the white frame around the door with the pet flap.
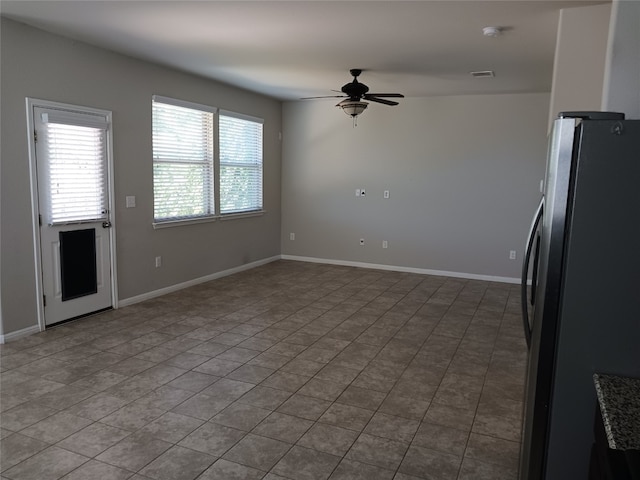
[25,97,118,332]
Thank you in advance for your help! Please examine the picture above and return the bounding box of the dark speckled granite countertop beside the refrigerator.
[593,373,640,450]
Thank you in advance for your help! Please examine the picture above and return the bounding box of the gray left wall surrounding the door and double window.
[0,18,282,335]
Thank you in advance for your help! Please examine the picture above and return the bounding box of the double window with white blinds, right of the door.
[153,95,262,224]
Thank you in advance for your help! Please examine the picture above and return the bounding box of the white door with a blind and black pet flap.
[33,106,112,325]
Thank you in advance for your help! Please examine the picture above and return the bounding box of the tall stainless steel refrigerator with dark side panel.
[520,112,640,480]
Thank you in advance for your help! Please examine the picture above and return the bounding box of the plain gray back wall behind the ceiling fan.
[282,93,549,278]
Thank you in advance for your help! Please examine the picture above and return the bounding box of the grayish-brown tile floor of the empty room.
[0,261,526,480]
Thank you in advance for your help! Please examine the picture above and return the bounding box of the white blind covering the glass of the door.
[42,113,107,225]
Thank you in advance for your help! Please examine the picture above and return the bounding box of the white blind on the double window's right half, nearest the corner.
[218,112,262,214]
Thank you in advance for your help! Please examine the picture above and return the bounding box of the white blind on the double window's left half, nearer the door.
[152,97,215,222]
